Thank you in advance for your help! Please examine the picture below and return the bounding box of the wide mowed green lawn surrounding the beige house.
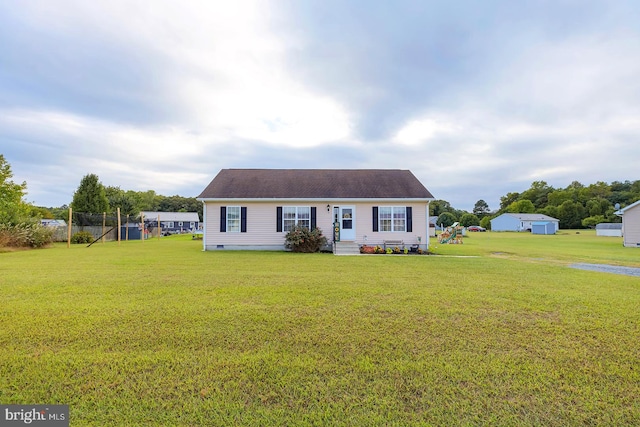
[0,232,640,426]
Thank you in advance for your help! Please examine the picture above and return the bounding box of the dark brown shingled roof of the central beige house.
[198,169,433,200]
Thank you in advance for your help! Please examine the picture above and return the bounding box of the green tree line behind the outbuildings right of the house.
[430,180,640,229]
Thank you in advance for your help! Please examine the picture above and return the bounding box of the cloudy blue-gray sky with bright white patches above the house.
[0,0,640,210]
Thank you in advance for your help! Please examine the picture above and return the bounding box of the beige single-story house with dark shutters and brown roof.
[197,169,433,250]
